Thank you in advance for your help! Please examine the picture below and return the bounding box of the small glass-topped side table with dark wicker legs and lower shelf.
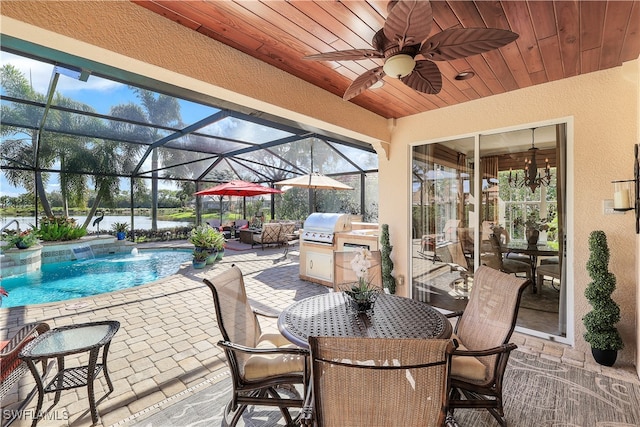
[20,321,120,427]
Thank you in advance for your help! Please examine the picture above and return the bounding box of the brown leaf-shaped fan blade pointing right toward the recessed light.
[420,28,518,61]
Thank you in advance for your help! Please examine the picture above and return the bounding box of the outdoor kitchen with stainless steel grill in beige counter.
[300,213,379,286]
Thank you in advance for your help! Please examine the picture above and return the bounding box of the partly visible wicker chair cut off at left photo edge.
[0,323,49,427]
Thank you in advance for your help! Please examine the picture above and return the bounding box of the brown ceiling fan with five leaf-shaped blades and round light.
[305,0,518,101]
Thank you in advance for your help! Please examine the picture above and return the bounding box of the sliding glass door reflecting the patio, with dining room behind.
[411,124,566,337]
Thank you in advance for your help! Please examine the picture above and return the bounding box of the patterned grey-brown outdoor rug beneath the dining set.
[127,351,640,427]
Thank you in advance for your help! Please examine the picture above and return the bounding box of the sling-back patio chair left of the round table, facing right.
[203,266,309,426]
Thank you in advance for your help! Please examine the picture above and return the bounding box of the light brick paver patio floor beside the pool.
[0,243,637,427]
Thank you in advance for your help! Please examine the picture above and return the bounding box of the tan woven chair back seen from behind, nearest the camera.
[302,337,455,427]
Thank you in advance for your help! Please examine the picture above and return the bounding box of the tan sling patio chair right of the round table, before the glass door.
[448,265,530,426]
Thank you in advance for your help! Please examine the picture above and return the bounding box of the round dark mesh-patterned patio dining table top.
[278,292,452,348]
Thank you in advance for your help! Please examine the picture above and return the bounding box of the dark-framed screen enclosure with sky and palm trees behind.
[0,48,378,232]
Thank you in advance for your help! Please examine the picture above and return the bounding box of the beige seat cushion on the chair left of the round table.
[244,334,304,380]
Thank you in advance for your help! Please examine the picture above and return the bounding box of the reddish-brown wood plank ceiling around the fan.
[132,0,640,118]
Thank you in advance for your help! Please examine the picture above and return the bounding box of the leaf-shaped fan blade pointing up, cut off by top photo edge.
[382,0,433,50]
